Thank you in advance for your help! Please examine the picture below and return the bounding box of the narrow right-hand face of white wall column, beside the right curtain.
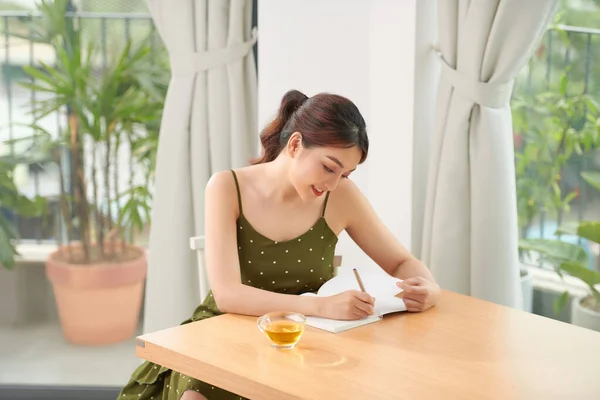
[367,0,417,256]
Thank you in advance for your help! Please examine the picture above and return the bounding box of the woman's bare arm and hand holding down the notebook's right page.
[337,180,440,311]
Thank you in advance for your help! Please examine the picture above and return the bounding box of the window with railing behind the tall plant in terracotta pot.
[0,0,164,398]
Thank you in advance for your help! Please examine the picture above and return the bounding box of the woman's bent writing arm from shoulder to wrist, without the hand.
[205,171,320,316]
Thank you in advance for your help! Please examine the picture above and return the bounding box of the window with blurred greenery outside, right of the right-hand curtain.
[511,0,600,269]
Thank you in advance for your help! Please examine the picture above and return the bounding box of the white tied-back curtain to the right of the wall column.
[421,0,557,308]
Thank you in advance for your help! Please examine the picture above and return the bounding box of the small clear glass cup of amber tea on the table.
[256,311,306,349]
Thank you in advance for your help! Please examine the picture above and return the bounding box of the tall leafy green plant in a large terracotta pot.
[17,0,164,345]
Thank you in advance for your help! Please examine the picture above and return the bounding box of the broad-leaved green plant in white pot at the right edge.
[520,172,600,331]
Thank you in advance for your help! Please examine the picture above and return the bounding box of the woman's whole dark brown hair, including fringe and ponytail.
[254,90,369,164]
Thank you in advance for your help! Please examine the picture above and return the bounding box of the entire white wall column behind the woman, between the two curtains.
[258,0,417,267]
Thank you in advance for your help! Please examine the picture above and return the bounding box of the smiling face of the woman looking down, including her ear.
[287,132,362,201]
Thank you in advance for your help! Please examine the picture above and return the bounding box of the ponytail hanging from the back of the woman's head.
[253,90,308,164]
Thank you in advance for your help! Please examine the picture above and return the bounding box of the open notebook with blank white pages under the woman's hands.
[302,267,406,333]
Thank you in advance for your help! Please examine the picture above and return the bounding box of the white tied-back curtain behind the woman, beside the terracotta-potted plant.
[144,0,258,332]
